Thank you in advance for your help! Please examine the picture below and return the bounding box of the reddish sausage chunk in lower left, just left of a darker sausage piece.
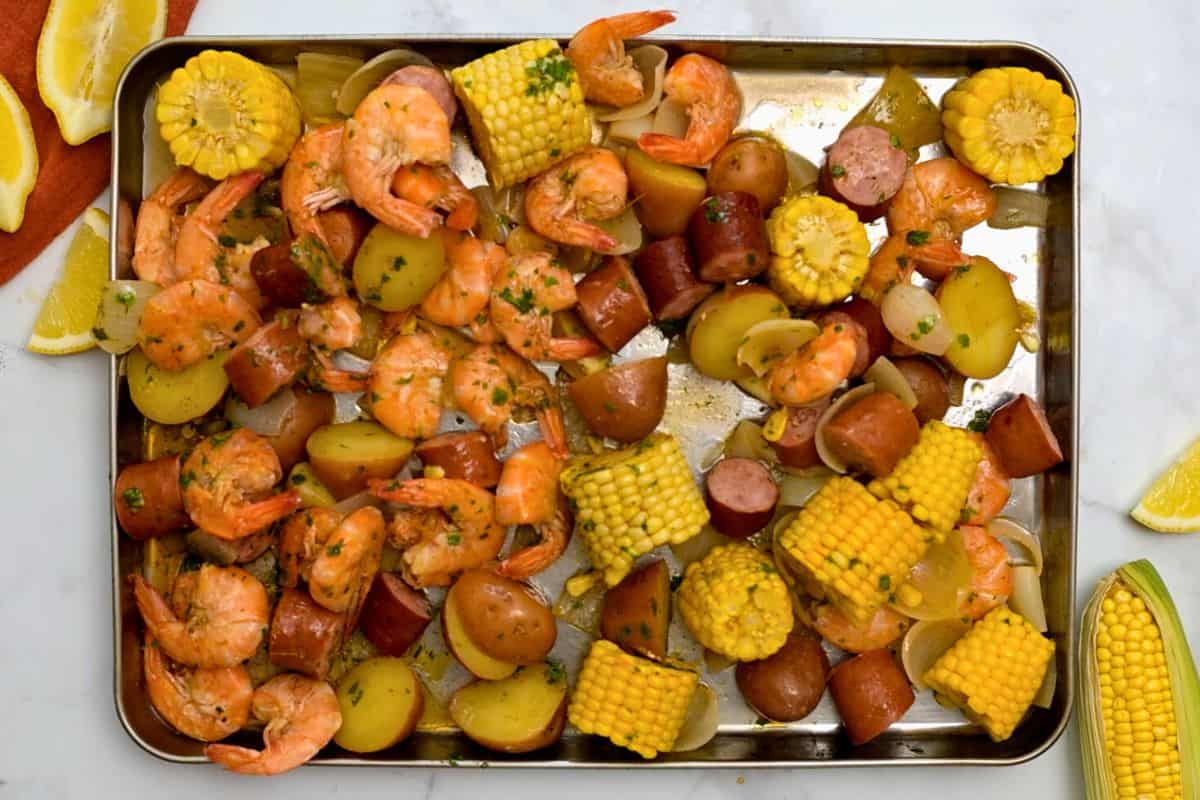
[268,589,346,680]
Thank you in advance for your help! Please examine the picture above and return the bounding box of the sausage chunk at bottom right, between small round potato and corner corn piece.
[829,650,914,745]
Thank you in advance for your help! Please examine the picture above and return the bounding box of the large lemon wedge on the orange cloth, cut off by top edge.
[37,0,167,144]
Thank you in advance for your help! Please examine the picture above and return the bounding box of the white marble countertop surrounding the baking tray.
[0,0,1200,800]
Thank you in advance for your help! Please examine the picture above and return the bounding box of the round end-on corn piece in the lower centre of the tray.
[676,542,793,661]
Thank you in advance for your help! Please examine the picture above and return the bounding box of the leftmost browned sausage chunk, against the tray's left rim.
[113,456,192,540]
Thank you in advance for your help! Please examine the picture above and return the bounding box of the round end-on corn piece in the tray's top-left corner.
[155,50,300,180]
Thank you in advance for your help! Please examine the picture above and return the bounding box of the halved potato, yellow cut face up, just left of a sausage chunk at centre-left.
[307,422,413,499]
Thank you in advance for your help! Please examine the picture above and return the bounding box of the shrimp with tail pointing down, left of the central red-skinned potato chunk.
[450,344,568,458]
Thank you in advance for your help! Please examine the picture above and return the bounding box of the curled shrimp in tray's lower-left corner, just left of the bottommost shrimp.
[142,637,254,741]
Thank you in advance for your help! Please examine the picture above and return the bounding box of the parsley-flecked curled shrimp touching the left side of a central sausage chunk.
[488,253,600,361]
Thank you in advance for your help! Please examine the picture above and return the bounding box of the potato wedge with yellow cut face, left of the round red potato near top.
[625,148,708,239]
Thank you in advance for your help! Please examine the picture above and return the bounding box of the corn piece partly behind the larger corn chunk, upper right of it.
[868,420,983,537]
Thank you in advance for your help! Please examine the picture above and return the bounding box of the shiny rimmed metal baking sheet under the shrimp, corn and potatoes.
[109,36,1079,769]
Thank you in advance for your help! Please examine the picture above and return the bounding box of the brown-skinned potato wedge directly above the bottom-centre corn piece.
[600,559,671,658]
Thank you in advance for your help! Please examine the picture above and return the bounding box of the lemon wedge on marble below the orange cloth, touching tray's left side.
[25,209,108,355]
